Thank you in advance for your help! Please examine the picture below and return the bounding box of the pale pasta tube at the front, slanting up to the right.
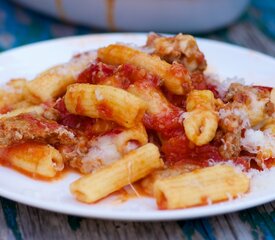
[70,143,163,203]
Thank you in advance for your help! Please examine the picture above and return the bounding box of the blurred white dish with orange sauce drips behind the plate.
[14,0,249,32]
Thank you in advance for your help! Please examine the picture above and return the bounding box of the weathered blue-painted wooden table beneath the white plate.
[0,0,275,240]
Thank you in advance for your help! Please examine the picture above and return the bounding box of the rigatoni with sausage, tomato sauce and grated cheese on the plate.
[0,33,275,209]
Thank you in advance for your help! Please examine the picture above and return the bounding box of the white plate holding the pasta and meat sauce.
[0,34,275,220]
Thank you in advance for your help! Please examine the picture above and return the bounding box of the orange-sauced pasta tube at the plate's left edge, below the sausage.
[5,143,64,178]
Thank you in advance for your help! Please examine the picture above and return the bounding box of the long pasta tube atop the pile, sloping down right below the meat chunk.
[98,44,191,95]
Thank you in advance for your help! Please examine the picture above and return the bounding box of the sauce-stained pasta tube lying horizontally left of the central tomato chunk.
[64,84,147,128]
